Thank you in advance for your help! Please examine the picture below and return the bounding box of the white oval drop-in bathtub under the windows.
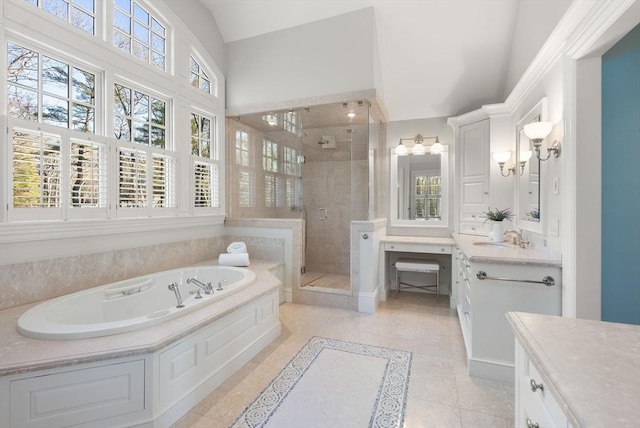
[17,266,256,339]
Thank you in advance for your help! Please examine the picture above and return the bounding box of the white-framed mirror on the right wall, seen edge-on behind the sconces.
[516,98,547,233]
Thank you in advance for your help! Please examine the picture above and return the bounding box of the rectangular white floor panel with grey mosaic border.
[231,337,412,428]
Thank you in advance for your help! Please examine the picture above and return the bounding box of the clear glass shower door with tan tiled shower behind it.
[301,102,368,294]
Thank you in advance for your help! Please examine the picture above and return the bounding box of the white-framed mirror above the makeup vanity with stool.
[390,149,449,227]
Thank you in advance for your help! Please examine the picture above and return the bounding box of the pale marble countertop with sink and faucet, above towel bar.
[453,233,562,267]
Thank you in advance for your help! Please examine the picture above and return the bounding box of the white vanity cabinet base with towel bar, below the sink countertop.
[455,247,562,381]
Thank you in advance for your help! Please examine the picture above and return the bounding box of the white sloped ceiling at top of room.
[200,0,553,121]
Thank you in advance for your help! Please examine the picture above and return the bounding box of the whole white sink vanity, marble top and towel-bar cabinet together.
[453,234,562,381]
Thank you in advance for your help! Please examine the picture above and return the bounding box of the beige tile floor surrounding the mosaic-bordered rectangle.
[172,292,514,428]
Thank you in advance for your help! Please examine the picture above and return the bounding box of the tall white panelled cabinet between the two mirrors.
[458,119,490,235]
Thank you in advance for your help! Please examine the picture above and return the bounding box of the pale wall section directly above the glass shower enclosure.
[227,8,374,114]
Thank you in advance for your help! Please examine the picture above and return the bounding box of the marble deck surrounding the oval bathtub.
[0,260,281,376]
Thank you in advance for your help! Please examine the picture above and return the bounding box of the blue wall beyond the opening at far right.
[602,25,640,324]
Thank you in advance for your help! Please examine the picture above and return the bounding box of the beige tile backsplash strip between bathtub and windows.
[0,237,226,310]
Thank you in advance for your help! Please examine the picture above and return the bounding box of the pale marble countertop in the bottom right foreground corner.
[507,312,640,428]
